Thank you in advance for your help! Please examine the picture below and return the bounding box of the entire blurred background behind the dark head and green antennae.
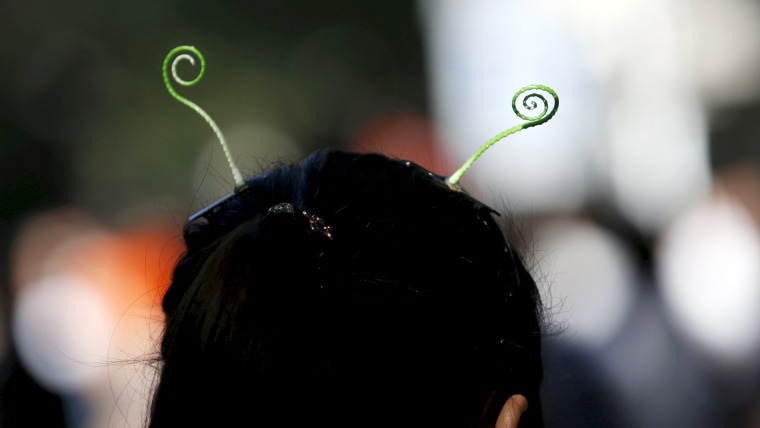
[0,0,760,428]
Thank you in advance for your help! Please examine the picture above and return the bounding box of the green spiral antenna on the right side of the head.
[446,85,559,192]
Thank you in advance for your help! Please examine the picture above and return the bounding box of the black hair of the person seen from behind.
[149,150,542,428]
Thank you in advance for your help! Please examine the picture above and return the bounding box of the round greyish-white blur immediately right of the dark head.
[534,220,636,348]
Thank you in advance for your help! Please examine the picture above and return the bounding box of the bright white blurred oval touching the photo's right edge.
[657,194,760,364]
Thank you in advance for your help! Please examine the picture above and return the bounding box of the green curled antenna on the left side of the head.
[163,46,245,190]
